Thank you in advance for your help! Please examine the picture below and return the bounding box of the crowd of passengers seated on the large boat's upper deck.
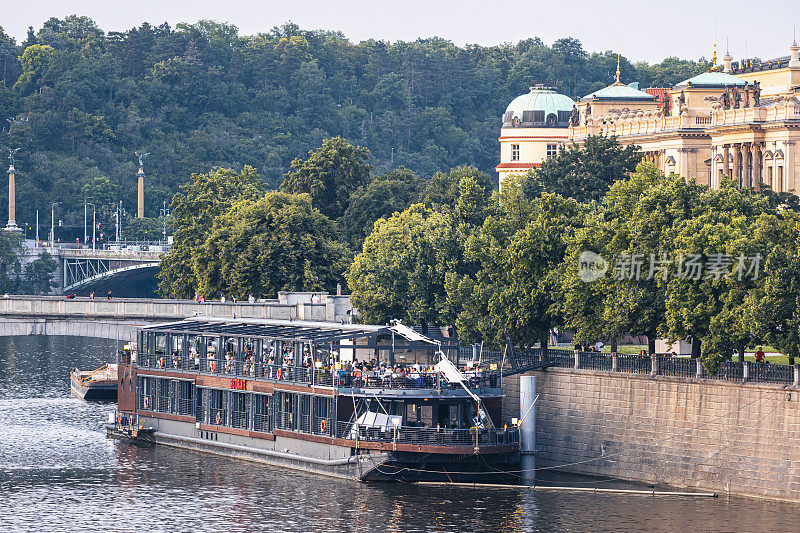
[149,342,484,387]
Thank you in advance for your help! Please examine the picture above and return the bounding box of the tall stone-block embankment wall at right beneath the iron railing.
[503,368,800,501]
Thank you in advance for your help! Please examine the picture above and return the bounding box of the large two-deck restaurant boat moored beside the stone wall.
[108,318,519,482]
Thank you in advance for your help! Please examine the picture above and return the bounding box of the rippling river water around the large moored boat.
[0,336,800,533]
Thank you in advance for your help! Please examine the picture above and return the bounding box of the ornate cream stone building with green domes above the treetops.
[497,43,800,192]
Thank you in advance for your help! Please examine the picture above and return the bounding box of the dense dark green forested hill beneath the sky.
[0,16,706,230]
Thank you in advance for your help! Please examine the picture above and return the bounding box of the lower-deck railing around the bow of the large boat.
[336,422,519,446]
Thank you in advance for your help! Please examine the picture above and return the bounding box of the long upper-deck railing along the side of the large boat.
[137,354,501,390]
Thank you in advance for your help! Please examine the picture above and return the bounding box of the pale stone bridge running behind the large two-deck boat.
[0,292,352,341]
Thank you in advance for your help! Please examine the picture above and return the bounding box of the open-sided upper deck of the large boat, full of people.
[136,318,502,397]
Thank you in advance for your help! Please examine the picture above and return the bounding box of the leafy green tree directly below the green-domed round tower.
[454,189,587,346]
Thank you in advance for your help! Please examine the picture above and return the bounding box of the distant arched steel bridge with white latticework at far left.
[57,247,164,294]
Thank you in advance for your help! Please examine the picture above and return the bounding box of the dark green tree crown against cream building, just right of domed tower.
[526,135,642,202]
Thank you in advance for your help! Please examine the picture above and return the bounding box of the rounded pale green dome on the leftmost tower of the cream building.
[503,86,575,128]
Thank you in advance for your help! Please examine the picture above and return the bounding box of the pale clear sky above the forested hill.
[0,0,800,62]
